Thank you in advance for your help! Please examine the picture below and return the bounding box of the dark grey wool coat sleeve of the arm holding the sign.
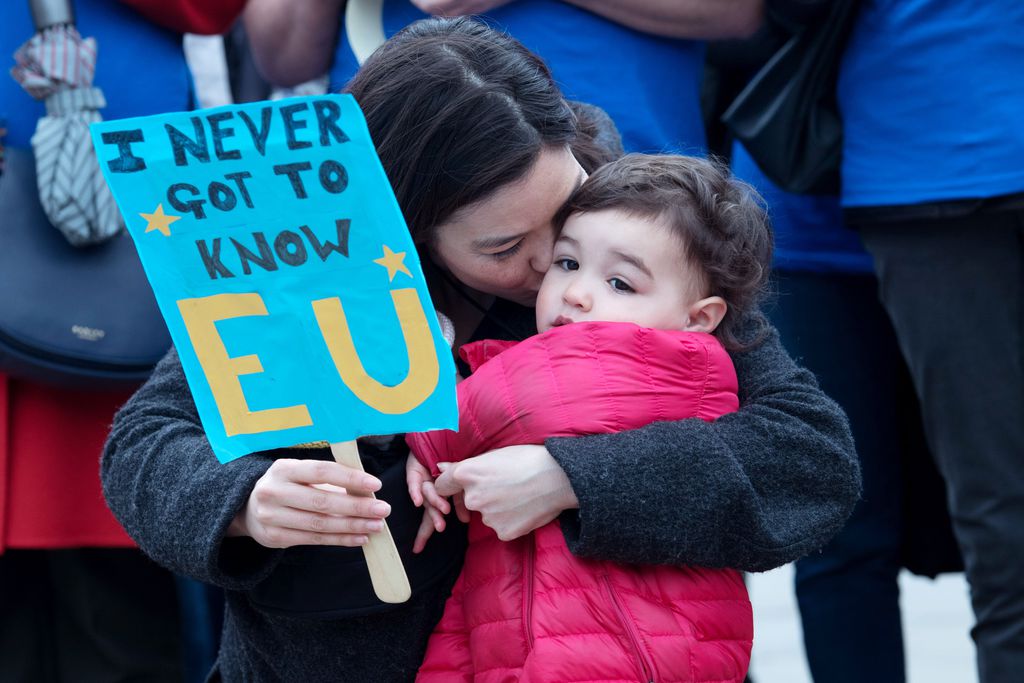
[100,349,281,590]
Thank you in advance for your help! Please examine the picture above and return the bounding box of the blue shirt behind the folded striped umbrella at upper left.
[0,0,191,149]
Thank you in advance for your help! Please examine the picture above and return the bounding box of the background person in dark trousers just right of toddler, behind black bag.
[705,0,963,683]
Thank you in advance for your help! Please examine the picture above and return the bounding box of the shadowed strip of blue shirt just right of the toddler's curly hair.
[732,143,873,273]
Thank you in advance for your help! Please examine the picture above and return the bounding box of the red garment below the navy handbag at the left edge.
[0,375,135,553]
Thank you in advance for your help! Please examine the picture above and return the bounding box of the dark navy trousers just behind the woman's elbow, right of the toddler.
[768,271,921,683]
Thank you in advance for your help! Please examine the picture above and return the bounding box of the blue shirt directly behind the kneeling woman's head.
[331,0,705,155]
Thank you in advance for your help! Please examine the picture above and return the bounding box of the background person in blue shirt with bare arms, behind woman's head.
[245,0,763,155]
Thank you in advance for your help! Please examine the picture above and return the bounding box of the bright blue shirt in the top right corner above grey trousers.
[838,0,1024,207]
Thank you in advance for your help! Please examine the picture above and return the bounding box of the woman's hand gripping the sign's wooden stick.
[227,459,391,548]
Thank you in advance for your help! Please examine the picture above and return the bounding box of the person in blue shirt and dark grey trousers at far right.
[838,0,1024,683]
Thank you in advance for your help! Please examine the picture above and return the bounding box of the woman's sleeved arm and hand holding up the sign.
[100,350,388,590]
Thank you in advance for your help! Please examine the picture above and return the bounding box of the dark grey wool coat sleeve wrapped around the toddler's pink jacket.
[546,323,860,571]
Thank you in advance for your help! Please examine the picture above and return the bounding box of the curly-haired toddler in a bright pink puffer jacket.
[408,155,771,683]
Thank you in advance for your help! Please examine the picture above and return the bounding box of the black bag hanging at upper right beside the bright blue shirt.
[722,0,857,194]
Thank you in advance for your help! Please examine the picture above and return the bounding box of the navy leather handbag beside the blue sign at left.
[0,147,171,389]
